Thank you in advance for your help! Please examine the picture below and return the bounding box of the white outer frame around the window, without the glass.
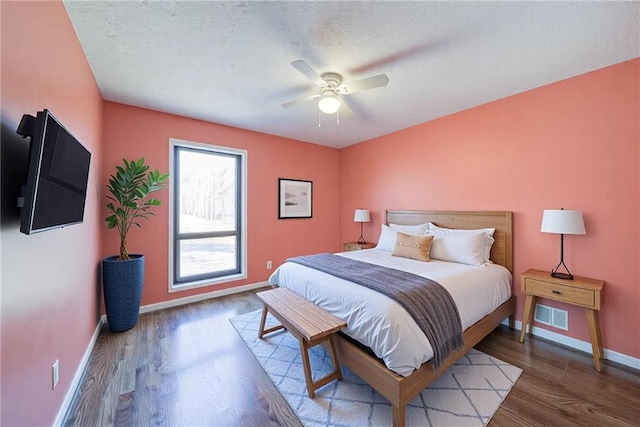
[169,138,248,293]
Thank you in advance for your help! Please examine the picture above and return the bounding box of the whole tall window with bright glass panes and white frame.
[169,139,247,291]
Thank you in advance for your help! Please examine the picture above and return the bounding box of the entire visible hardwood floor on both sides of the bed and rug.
[64,292,640,427]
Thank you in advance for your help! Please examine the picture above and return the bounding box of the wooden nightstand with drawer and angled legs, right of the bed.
[520,270,604,372]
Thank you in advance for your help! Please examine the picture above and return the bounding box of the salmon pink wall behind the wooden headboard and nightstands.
[340,59,640,358]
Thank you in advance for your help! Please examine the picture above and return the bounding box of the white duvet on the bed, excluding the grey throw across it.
[269,249,511,376]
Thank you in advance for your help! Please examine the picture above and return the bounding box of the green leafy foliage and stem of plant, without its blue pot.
[105,157,169,260]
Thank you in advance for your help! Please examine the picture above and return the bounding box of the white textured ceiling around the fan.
[64,1,640,147]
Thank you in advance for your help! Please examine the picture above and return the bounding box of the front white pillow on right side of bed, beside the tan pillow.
[425,230,486,266]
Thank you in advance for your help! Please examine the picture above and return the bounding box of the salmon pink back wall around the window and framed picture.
[101,102,340,305]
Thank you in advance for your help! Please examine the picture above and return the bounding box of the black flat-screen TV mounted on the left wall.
[18,110,91,234]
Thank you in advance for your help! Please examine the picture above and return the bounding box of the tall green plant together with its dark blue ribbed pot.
[102,158,169,332]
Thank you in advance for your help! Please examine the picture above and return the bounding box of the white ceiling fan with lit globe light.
[282,59,389,114]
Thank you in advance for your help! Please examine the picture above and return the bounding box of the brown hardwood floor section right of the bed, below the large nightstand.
[476,326,640,427]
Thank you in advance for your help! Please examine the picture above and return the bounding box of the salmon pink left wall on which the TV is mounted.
[0,1,102,426]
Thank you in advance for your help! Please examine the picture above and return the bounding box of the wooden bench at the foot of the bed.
[256,288,347,399]
